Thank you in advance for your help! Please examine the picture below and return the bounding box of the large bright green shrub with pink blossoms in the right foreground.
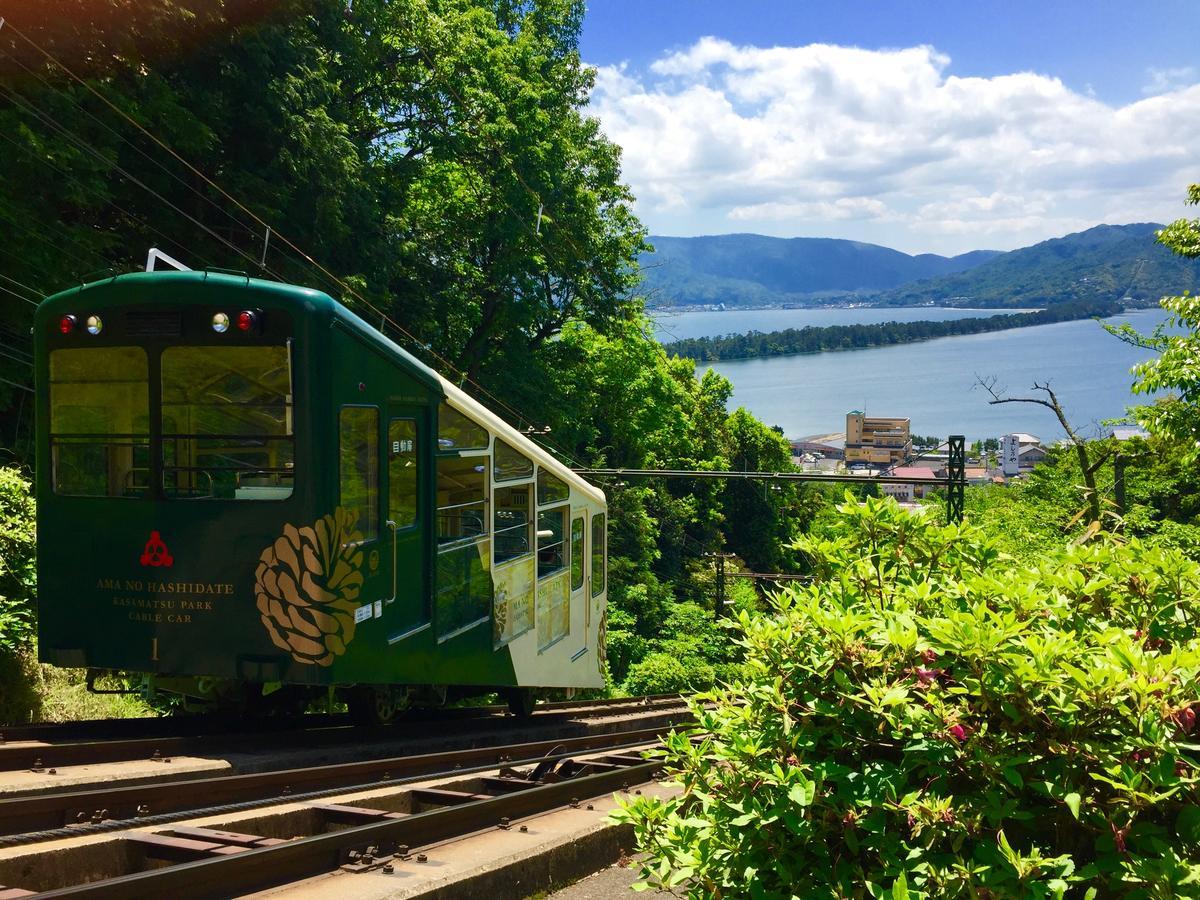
[618,500,1200,898]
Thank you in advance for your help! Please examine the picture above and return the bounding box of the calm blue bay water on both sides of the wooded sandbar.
[680,308,1166,440]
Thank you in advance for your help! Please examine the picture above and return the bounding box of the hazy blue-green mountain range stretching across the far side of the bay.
[642,223,1200,308]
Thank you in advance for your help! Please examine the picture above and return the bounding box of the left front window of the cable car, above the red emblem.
[50,347,150,497]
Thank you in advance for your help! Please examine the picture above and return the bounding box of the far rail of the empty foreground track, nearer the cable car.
[0,718,690,846]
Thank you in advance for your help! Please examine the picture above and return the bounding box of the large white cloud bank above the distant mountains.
[593,37,1200,253]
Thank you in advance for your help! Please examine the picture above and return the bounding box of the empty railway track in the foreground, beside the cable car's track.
[0,698,686,900]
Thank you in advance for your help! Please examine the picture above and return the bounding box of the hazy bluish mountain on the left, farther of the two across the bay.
[640,234,995,306]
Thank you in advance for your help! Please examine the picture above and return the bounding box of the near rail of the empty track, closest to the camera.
[38,762,661,900]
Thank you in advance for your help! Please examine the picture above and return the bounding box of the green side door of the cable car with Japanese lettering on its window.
[380,404,430,644]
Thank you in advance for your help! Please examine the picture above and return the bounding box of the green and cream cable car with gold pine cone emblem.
[35,271,607,720]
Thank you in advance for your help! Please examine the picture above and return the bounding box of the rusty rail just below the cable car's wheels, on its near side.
[0,695,682,772]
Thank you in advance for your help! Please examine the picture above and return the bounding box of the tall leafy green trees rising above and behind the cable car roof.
[0,0,643,453]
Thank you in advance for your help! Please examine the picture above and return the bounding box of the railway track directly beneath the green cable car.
[0,695,682,773]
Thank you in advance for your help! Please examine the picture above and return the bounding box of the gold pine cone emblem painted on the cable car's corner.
[254,508,362,666]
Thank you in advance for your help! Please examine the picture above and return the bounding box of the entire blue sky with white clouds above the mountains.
[582,0,1200,253]
